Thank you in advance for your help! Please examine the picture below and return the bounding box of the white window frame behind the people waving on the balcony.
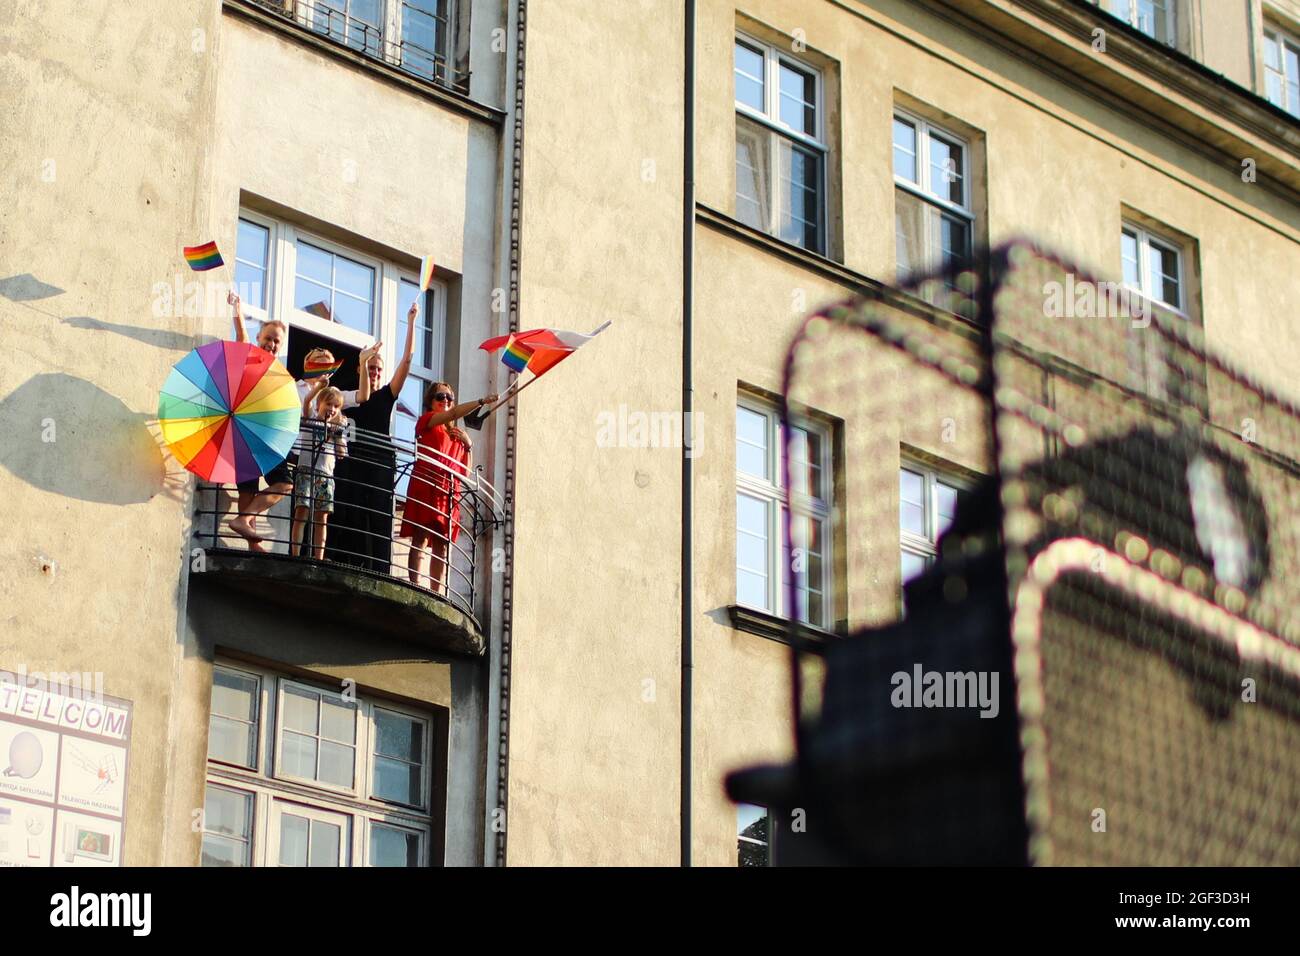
[235,208,447,390]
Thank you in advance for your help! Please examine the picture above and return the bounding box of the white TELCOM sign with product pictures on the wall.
[0,682,131,866]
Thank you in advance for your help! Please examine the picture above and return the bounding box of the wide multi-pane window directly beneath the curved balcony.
[202,663,441,866]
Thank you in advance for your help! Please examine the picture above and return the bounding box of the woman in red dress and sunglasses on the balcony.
[398,381,497,592]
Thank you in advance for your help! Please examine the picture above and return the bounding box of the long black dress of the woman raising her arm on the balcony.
[325,382,398,574]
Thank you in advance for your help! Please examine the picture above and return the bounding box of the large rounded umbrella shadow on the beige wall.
[0,372,166,505]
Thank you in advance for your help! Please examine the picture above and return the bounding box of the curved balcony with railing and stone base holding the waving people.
[191,424,504,657]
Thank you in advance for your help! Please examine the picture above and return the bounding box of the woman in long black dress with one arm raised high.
[326,299,420,574]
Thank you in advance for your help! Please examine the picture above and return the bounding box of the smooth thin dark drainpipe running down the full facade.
[681,0,696,866]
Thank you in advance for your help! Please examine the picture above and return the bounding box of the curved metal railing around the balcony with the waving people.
[194,419,504,617]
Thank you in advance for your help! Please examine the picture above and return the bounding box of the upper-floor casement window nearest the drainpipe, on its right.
[735,34,827,252]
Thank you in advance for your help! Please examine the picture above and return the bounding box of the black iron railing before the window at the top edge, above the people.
[244,0,469,92]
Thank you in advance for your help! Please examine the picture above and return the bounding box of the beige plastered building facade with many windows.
[0,0,1300,866]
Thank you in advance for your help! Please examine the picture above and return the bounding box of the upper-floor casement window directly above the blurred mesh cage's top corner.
[893,111,975,283]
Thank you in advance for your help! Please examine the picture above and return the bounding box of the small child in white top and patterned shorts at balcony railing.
[290,378,347,561]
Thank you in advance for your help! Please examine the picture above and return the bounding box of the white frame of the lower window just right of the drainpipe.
[732,393,835,630]
